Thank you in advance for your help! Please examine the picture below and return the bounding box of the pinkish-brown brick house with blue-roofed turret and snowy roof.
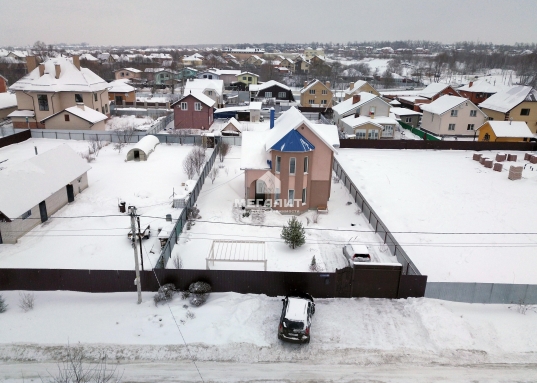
[241,107,339,214]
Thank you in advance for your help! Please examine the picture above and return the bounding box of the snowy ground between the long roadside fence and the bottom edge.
[0,291,537,382]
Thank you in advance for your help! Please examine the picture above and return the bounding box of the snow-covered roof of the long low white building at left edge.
[0,144,91,219]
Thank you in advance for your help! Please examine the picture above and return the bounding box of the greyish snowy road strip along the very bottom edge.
[0,361,537,383]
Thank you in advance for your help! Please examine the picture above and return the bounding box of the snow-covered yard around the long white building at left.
[0,139,201,270]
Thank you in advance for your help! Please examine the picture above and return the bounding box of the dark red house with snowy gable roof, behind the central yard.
[171,92,215,130]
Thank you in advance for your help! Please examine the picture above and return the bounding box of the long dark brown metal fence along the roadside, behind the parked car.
[0,266,427,298]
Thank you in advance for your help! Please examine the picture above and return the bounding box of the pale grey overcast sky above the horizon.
[0,0,537,46]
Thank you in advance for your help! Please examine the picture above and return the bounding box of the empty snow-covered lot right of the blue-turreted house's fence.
[336,149,537,284]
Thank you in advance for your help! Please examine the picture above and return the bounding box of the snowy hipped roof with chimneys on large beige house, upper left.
[9,57,108,92]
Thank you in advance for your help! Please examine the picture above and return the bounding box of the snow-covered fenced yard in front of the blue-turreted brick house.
[168,146,396,272]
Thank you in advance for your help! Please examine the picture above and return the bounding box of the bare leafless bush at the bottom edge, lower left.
[42,346,123,383]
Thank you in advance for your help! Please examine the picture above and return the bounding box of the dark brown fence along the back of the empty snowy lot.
[339,139,537,151]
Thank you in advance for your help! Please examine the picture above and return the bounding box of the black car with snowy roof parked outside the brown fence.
[278,293,315,343]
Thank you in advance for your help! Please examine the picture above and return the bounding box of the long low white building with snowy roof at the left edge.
[0,144,91,243]
